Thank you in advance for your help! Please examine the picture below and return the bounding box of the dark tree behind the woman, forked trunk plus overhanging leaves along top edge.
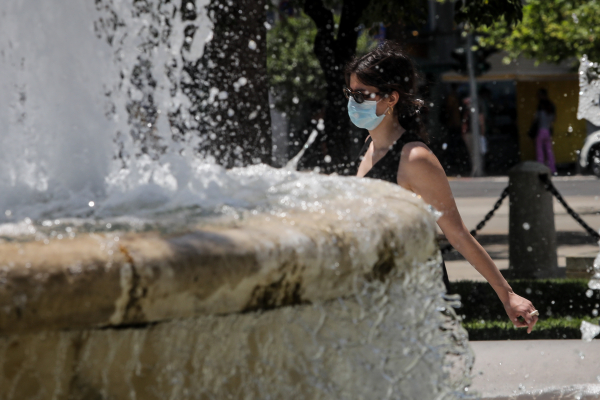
[270,0,521,173]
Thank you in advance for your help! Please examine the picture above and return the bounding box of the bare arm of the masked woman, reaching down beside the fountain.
[398,142,537,333]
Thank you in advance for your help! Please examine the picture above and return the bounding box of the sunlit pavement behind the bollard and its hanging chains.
[446,176,600,281]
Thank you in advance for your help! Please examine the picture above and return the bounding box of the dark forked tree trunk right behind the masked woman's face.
[304,0,370,174]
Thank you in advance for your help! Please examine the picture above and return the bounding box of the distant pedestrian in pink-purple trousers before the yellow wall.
[534,88,556,174]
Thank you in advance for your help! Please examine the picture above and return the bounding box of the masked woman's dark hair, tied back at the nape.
[344,41,429,143]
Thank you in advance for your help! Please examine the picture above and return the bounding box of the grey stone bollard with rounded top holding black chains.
[508,161,561,278]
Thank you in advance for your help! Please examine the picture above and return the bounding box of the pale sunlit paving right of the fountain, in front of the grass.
[470,340,600,400]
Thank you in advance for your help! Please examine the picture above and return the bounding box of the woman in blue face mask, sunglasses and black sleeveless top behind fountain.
[344,42,538,333]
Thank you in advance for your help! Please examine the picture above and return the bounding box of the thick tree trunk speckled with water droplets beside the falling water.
[189,0,272,168]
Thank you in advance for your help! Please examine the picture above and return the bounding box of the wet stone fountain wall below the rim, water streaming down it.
[0,267,472,400]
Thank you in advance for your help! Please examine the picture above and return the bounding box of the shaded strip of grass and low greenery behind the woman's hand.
[450,279,600,340]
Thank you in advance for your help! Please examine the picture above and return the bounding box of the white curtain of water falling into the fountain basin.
[0,0,214,222]
